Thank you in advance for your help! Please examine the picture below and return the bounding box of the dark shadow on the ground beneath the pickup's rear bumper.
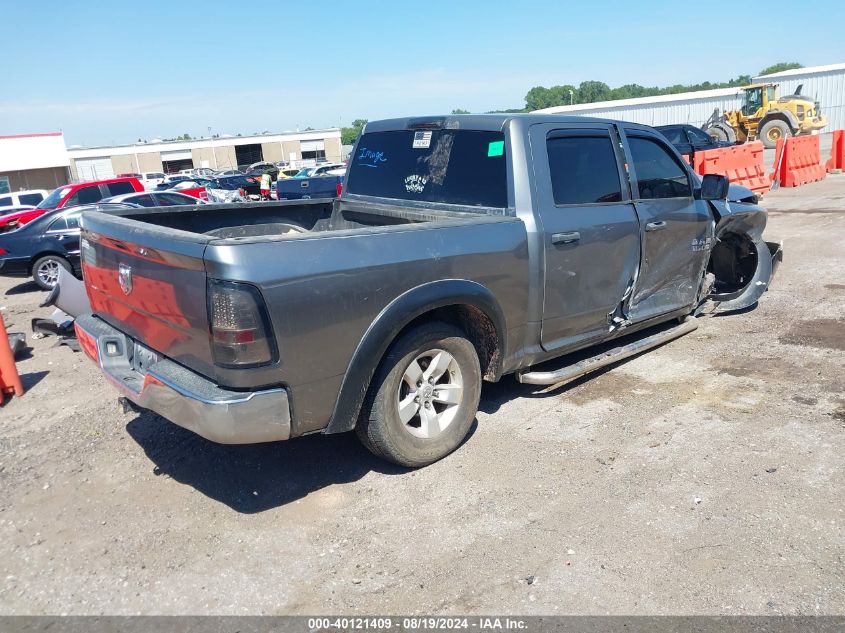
[126,412,468,514]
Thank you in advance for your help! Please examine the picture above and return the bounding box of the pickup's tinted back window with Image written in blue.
[346,130,508,208]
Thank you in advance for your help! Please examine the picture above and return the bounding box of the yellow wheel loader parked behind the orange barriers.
[702,84,827,149]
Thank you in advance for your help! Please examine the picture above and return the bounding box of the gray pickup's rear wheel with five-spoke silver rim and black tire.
[355,322,481,468]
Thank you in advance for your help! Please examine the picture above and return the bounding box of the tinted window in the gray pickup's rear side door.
[546,134,622,205]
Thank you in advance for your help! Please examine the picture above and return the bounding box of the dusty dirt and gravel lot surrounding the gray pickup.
[0,176,845,615]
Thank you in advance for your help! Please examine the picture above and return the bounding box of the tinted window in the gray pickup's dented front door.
[628,136,692,200]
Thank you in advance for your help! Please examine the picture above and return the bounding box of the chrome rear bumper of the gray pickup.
[76,315,290,444]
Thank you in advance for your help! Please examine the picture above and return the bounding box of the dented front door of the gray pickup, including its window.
[623,128,714,321]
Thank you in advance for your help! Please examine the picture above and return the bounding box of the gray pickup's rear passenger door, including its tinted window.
[530,123,640,349]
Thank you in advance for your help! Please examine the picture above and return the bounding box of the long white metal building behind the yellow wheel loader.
[535,64,845,132]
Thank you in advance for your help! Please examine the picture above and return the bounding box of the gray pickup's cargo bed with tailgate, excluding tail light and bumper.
[82,199,529,435]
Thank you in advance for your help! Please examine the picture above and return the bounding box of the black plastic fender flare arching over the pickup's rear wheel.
[324,279,506,433]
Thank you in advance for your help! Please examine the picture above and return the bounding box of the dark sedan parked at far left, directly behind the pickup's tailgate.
[0,204,134,290]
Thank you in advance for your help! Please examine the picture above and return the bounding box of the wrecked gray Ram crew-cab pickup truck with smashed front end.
[76,115,781,466]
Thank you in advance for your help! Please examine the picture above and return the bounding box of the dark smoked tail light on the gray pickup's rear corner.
[208,279,276,367]
